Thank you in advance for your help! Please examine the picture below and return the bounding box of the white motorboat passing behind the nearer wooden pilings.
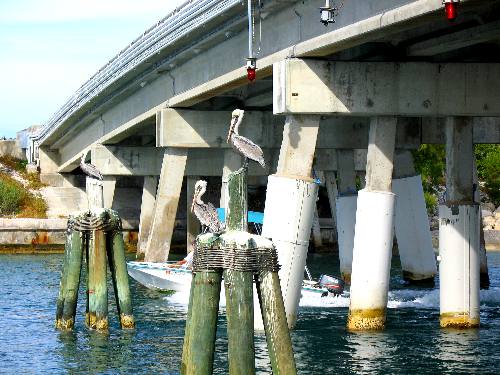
[127,261,343,296]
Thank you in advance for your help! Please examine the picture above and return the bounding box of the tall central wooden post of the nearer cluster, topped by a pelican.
[224,167,255,375]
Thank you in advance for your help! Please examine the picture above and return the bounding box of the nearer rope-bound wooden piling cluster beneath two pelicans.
[181,168,296,375]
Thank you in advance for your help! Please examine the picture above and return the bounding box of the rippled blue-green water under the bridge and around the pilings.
[0,253,500,374]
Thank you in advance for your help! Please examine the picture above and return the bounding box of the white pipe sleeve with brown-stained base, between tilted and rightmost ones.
[347,190,395,330]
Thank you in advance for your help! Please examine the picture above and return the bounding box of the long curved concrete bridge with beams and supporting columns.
[31,0,500,329]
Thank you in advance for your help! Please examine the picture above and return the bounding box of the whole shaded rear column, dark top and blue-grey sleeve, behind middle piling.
[336,150,358,283]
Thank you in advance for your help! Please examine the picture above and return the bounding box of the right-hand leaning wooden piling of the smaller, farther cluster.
[106,210,135,329]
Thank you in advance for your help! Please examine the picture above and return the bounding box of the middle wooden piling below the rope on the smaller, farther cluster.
[88,230,108,331]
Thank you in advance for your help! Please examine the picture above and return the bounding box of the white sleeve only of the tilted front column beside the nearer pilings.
[257,176,318,328]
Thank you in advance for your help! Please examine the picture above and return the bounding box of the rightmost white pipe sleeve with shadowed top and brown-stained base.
[439,204,480,328]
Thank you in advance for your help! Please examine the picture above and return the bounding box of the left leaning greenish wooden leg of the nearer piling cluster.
[181,258,222,375]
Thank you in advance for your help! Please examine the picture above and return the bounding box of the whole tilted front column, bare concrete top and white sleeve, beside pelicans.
[263,115,319,328]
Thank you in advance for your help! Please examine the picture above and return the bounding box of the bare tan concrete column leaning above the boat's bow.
[144,147,187,262]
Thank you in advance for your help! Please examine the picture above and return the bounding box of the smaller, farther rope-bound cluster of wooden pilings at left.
[56,209,135,331]
